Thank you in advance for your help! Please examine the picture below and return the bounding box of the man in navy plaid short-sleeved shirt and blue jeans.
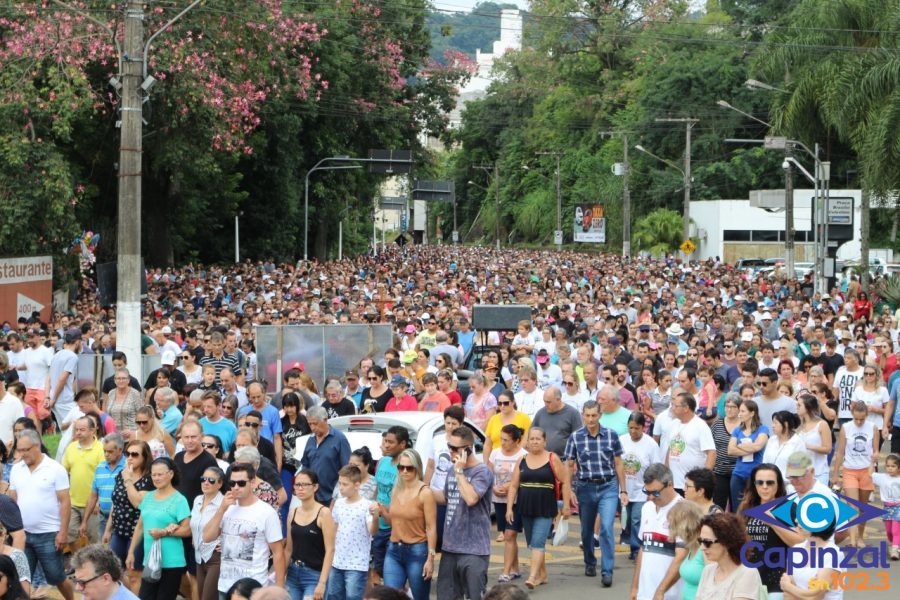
[561,398,628,587]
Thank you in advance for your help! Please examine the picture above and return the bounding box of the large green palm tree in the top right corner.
[758,0,900,288]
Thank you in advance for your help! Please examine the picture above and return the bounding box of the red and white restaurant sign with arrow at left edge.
[0,256,53,324]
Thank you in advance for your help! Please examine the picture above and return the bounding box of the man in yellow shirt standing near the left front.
[62,417,104,544]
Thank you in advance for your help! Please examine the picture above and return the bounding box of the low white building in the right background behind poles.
[691,189,862,262]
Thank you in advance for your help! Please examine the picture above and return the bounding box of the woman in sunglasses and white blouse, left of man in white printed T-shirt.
[191,467,225,600]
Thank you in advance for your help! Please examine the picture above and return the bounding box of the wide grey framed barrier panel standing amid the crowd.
[256,324,393,392]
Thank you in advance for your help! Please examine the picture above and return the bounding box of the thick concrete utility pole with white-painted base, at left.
[116,0,144,379]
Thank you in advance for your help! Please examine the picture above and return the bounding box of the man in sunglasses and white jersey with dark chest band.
[631,463,687,600]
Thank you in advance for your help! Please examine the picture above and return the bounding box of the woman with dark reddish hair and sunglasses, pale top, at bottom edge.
[695,513,762,600]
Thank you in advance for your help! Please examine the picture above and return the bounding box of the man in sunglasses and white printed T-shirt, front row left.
[203,463,285,594]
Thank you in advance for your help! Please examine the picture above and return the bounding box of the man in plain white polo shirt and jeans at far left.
[8,428,74,600]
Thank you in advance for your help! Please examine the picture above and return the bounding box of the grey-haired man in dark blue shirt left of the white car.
[300,406,350,505]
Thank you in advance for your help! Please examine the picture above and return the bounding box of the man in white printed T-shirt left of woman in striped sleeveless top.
[665,392,716,497]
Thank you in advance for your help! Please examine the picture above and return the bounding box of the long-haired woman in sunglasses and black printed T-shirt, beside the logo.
[737,464,804,600]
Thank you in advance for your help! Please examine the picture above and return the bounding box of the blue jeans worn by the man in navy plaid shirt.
[575,479,619,577]
